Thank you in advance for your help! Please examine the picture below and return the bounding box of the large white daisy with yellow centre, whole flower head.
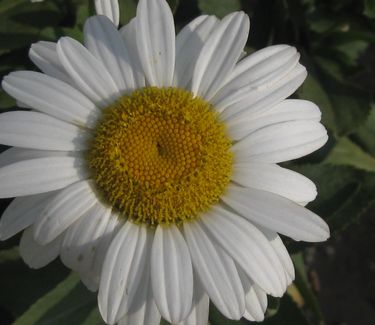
[0,0,329,325]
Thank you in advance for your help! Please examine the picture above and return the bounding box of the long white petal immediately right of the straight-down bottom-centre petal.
[184,222,245,319]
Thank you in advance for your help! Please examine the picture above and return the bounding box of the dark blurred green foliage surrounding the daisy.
[0,0,375,325]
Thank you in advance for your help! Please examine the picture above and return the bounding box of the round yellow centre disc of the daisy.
[88,87,233,226]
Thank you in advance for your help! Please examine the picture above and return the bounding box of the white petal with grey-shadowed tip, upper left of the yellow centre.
[84,16,136,93]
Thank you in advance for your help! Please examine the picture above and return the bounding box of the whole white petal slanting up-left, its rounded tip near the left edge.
[2,71,99,127]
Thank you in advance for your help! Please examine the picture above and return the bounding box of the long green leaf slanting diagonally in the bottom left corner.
[14,274,104,325]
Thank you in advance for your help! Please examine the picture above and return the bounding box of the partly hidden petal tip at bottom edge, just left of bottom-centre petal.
[118,275,161,325]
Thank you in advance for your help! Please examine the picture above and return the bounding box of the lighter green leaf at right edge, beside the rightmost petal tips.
[325,138,375,172]
